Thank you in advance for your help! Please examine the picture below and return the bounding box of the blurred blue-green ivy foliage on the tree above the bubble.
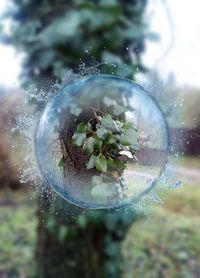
[1,0,147,88]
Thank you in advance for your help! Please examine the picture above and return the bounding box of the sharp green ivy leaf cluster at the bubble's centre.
[67,96,139,176]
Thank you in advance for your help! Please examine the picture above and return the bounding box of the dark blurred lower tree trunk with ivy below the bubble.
[36,191,135,278]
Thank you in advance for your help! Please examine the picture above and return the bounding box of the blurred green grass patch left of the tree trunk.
[0,191,37,278]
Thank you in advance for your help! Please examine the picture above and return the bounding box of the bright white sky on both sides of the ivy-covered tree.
[0,0,200,87]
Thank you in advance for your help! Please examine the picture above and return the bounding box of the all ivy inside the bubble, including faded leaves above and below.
[58,91,140,195]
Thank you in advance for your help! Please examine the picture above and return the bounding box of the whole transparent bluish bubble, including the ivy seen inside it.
[35,74,168,209]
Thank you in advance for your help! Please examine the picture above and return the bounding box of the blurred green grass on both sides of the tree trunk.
[0,157,200,278]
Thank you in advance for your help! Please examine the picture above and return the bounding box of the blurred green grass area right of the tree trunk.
[123,186,200,278]
